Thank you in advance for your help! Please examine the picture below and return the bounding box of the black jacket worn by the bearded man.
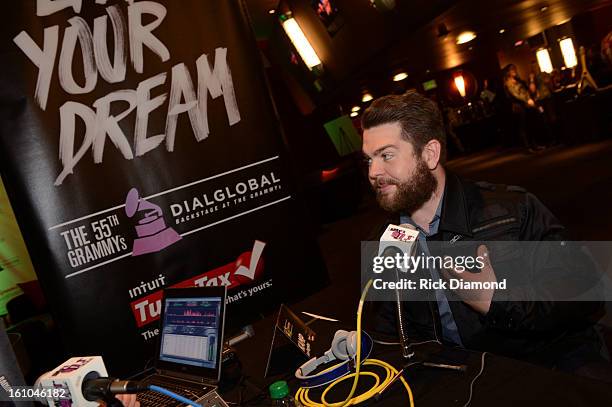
[371,171,602,369]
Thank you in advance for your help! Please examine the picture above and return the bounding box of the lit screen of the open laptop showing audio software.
[158,287,225,378]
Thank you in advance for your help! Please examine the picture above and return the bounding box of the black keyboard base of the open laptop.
[137,376,213,407]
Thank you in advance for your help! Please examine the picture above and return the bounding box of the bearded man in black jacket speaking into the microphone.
[362,91,612,379]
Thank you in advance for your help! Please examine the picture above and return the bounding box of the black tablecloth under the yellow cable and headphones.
[224,330,612,407]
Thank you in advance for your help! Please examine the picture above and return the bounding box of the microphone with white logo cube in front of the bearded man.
[379,224,419,359]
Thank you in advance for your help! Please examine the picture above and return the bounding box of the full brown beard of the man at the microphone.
[376,160,438,214]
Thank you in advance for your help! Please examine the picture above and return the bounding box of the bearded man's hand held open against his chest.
[440,245,497,315]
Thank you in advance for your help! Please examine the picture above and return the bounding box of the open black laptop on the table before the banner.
[138,286,227,407]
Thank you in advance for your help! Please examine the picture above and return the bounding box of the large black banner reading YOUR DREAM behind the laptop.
[0,0,327,374]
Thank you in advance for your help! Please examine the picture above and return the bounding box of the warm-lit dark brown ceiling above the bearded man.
[247,0,612,107]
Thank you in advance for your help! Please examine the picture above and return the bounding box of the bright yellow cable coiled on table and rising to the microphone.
[295,280,414,407]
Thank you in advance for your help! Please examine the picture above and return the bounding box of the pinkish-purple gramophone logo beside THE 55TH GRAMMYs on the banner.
[125,188,181,256]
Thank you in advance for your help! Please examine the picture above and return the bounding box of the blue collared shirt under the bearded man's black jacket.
[400,196,463,346]
